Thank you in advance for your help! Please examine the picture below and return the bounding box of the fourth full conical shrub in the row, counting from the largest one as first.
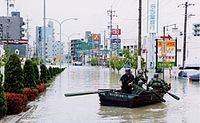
[40,64,47,83]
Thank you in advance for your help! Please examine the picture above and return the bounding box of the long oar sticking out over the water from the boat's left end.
[64,89,116,97]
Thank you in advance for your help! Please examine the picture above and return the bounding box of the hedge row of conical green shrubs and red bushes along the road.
[0,52,64,119]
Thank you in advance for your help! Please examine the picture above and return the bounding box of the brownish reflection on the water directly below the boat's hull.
[98,103,167,123]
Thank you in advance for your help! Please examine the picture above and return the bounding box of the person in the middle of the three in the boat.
[134,69,148,87]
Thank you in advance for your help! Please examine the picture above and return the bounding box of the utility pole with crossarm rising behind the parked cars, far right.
[178,2,194,68]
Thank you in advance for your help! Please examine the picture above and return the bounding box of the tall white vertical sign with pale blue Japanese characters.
[147,0,158,33]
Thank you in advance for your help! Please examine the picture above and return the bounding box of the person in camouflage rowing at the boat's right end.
[147,73,171,93]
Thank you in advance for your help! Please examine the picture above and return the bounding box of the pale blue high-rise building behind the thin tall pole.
[36,21,56,62]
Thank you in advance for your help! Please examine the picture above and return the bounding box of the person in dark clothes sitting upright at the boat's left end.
[120,67,134,94]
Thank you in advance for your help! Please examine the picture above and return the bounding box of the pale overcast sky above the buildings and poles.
[0,0,200,50]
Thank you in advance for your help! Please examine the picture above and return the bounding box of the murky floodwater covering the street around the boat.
[6,66,200,123]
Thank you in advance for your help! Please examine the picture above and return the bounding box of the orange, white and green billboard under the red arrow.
[156,39,177,68]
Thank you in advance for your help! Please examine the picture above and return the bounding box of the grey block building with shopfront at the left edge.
[0,12,28,57]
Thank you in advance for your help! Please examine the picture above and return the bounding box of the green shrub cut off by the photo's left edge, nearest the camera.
[0,73,7,119]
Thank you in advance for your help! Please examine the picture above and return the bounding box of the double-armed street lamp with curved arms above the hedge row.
[46,18,78,68]
